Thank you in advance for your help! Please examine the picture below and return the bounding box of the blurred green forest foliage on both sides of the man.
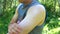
[0,0,60,34]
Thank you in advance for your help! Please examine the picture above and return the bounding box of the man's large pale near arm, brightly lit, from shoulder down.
[19,5,45,34]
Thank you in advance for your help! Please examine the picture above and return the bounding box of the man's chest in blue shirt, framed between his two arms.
[18,5,29,21]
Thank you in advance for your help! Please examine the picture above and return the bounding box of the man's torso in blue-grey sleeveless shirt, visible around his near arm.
[18,1,44,34]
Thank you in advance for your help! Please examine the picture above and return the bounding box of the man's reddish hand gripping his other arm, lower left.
[8,23,21,34]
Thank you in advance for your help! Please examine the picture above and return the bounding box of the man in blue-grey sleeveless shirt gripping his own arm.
[8,0,46,34]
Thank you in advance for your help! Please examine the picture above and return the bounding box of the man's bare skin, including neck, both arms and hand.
[8,0,45,34]
